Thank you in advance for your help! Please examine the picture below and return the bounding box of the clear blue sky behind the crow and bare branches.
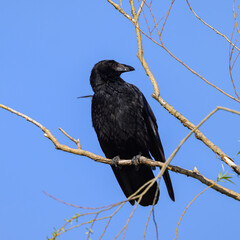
[0,0,240,240]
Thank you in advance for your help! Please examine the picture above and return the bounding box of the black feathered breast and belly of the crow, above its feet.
[92,86,148,158]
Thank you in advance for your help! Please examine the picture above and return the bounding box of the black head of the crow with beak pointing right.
[90,60,135,91]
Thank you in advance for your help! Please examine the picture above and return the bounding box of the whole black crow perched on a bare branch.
[90,60,175,206]
